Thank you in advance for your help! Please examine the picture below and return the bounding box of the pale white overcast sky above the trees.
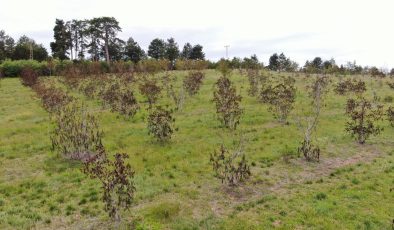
[0,0,394,69]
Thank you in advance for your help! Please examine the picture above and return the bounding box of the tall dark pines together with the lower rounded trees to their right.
[50,17,205,63]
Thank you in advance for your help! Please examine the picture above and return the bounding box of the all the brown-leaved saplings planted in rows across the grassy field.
[21,68,394,225]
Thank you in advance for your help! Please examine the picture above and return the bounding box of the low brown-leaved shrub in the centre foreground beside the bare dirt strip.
[209,144,251,186]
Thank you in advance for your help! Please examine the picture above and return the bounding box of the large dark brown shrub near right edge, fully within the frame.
[346,96,383,144]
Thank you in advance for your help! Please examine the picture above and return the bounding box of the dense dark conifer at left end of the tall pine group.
[50,19,71,60]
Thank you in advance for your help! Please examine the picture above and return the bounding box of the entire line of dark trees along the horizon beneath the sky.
[0,17,394,76]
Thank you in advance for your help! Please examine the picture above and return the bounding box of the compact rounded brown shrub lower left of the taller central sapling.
[148,106,175,142]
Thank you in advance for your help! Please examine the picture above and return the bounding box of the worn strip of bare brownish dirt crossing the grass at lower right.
[210,144,382,216]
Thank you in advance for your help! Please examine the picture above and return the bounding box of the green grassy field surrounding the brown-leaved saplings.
[0,71,394,229]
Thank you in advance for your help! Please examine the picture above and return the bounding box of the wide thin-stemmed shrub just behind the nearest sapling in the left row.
[51,103,103,160]
